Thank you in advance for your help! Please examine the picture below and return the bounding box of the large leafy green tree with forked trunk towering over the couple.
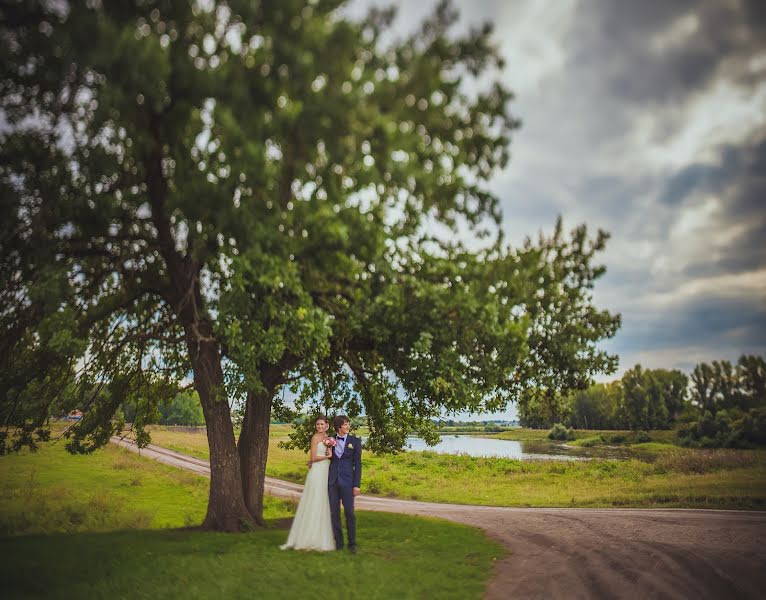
[0,0,619,530]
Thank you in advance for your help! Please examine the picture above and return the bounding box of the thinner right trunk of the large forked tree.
[239,386,274,525]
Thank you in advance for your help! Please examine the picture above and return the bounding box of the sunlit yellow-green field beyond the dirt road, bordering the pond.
[142,425,766,510]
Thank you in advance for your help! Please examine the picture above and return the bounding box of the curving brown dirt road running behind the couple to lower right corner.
[112,437,766,600]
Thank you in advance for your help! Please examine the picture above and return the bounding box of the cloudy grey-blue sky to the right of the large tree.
[350,0,766,419]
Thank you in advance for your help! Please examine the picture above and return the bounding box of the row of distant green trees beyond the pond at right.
[519,356,766,445]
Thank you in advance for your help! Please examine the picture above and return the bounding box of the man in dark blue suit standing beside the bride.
[327,415,362,554]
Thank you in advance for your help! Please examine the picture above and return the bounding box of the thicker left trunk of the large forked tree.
[187,331,253,531]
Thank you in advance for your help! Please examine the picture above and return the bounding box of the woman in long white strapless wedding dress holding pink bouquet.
[280,415,335,550]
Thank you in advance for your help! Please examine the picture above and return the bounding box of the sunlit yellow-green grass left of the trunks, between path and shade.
[0,444,220,534]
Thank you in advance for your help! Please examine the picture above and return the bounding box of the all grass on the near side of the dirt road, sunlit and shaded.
[0,434,505,600]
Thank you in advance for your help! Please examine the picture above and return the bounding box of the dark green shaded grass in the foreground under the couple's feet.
[0,511,504,600]
